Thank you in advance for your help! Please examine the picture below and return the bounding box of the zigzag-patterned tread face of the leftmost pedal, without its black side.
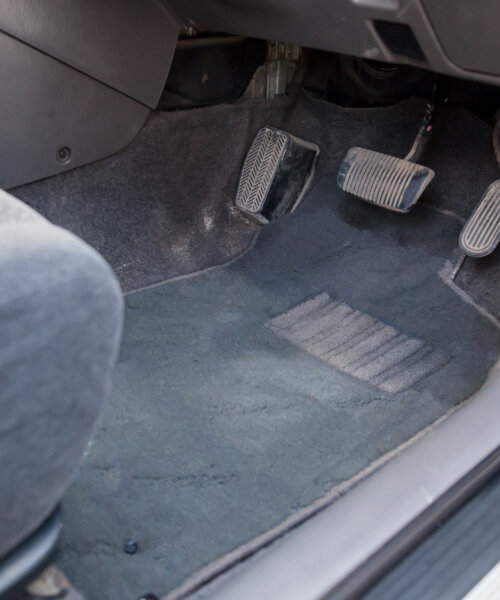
[236,127,289,215]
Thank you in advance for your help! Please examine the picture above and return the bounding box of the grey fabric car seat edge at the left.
[0,190,123,558]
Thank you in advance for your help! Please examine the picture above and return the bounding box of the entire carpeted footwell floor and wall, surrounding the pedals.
[11,89,500,600]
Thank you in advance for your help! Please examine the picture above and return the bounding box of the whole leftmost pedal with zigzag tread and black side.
[235,127,319,225]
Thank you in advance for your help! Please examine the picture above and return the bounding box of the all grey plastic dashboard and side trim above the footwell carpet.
[0,0,500,189]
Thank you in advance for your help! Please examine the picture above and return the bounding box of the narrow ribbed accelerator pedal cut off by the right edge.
[460,179,500,258]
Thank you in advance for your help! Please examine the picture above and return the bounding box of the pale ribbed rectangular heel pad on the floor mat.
[267,294,448,394]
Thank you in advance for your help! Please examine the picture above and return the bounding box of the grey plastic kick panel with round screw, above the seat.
[0,33,149,189]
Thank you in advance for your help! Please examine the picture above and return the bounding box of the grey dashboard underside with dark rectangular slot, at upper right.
[169,0,500,84]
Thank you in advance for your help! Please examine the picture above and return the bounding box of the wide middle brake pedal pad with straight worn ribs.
[337,147,434,212]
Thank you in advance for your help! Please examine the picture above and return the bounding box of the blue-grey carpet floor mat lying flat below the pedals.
[51,101,500,600]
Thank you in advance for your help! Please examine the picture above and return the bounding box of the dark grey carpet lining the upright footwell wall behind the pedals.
[11,93,499,302]
